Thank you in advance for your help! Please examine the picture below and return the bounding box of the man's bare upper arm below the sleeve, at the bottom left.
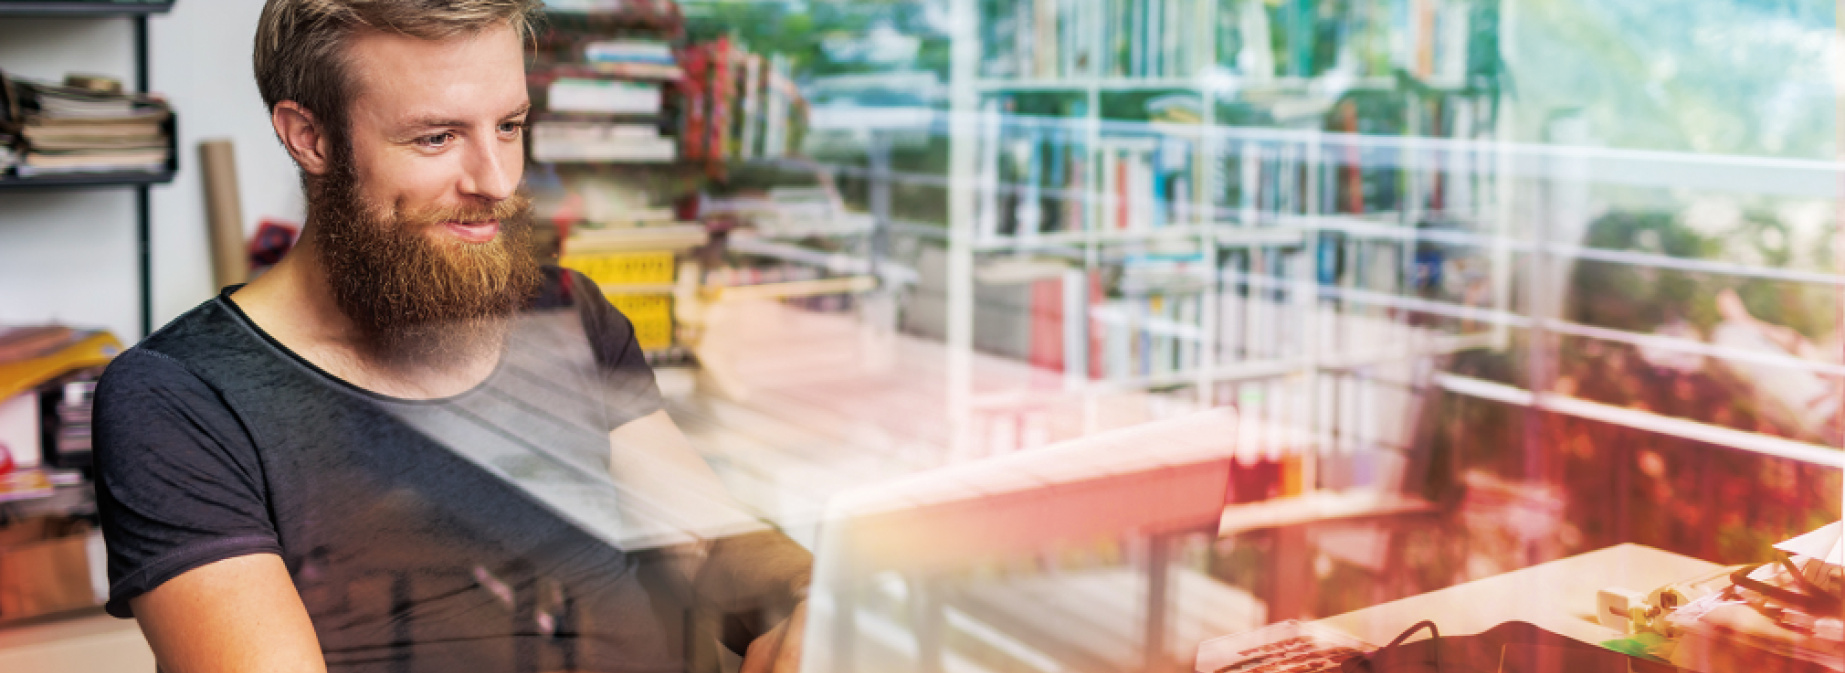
[129,553,327,673]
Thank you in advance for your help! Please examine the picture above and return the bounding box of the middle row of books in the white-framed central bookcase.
[974,96,1489,238]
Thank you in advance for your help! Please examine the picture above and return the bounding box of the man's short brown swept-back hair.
[255,0,542,133]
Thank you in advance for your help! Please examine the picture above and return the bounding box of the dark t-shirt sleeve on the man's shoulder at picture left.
[94,348,282,618]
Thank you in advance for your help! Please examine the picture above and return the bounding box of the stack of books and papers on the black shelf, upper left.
[0,76,172,177]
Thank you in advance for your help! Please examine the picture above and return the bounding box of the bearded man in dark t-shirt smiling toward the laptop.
[96,0,810,673]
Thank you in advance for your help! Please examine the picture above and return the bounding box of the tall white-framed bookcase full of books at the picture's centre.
[943,0,1511,492]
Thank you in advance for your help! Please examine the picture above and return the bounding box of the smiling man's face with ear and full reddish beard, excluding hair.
[308,24,539,358]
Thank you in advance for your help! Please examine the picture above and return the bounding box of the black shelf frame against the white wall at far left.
[0,0,179,336]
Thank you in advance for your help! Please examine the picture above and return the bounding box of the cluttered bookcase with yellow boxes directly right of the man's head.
[528,0,841,365]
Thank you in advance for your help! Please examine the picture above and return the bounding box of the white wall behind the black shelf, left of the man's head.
[0,0,303,339]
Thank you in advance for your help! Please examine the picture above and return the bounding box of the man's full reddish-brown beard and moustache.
[308,153,542,365]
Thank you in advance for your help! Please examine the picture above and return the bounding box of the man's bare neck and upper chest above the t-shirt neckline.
[231,236,500,400]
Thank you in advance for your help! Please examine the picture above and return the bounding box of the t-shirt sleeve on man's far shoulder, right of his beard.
[561,265,675,430]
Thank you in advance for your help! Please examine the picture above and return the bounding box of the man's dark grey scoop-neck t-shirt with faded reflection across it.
[96,269,789,671]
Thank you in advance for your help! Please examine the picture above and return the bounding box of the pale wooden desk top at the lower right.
[1317,544,1721,647]
